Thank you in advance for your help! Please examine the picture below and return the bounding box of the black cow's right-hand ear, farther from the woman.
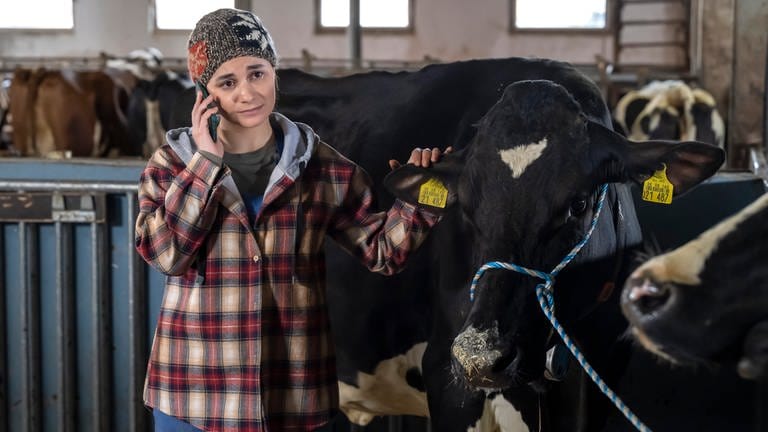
[587,121,725,196]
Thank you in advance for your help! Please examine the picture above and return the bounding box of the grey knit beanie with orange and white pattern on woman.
[187,9,277,85]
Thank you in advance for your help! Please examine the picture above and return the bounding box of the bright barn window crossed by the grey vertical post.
[316,0,413,30]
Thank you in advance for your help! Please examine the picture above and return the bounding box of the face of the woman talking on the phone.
[208,56,276,128]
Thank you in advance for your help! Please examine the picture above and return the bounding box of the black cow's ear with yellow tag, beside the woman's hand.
[384,153,464,213]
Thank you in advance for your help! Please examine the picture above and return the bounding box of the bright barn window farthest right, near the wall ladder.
[511,0,608,30]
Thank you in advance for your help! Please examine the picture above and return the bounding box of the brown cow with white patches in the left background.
[9,68,133,157]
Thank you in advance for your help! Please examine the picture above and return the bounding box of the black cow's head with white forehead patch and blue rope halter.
[388,81,724,389]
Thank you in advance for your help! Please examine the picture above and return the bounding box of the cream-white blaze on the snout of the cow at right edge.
[632,194,768,285]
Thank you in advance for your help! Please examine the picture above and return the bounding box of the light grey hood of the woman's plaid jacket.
[165,112,318,196]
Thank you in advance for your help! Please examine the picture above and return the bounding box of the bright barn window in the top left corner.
[0,0,75,30]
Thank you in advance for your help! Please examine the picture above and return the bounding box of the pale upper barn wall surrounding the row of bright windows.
[0,0,613,63]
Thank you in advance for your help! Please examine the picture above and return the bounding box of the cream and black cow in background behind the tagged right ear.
[614,80,725,148]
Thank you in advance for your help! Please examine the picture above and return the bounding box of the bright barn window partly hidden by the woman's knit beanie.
[155,0,238,30]
